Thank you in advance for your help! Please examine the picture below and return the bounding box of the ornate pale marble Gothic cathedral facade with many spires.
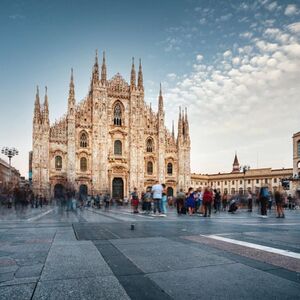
[32,53,191,199]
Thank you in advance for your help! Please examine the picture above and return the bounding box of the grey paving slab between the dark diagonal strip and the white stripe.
[111,238,234,273]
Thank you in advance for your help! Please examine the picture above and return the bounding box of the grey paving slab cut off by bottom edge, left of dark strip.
[33,276,130,300]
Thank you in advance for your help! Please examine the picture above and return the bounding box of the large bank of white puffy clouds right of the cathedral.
[165,23,300,172]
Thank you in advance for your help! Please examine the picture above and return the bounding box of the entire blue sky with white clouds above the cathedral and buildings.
[0,0,300,176]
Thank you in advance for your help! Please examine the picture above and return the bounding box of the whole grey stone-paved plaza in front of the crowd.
[0,206,300,300]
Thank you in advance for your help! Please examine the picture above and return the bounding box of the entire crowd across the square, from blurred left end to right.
[2,182,296,218]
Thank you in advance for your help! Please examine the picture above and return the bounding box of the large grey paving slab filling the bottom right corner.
[147,264,300,300]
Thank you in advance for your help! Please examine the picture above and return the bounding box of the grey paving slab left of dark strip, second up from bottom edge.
[41,241,112,281]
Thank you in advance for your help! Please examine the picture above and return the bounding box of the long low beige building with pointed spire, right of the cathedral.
[191,154,292,195]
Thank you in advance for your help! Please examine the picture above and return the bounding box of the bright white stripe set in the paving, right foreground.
[200,234,300,259]
